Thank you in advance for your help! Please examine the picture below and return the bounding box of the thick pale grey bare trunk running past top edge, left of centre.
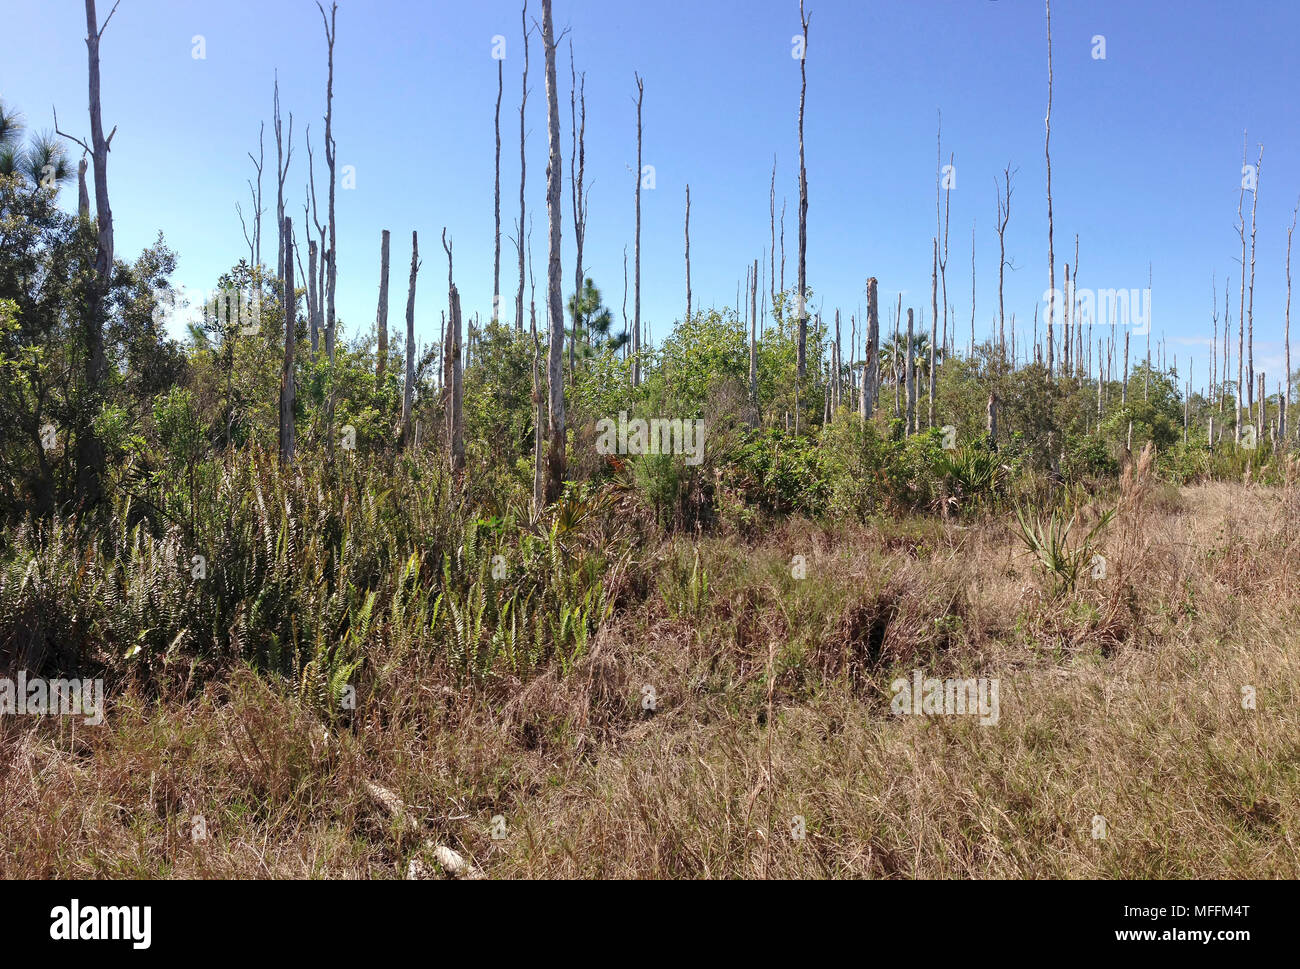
[542,0,566,505]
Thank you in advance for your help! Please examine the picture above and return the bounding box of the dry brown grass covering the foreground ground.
[0,481,1300,878]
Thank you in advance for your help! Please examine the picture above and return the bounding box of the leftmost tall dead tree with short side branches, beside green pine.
[55,0,121,506]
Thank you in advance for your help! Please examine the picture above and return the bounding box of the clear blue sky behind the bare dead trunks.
[0,0,1300,392]
